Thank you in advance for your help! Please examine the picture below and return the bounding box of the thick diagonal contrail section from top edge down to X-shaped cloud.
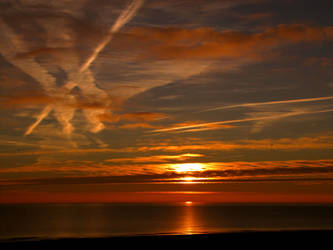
[80,0,144,72]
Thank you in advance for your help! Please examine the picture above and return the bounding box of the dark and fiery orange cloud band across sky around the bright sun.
[0,159,333,186]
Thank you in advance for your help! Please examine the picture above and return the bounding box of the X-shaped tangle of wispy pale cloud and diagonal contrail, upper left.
[0,0,144,135]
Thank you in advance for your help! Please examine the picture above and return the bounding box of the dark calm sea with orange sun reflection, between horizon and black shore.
[0,202,333,240]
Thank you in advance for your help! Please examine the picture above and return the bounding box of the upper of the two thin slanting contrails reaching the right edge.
[196,96,333,113]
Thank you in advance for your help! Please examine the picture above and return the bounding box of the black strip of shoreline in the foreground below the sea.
[0,230,333,249]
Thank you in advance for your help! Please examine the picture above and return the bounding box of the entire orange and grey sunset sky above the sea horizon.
[0,0,333,203]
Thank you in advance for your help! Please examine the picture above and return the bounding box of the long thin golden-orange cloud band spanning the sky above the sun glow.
[0,135,333,157]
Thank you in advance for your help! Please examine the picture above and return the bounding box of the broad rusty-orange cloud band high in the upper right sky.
[119,24,333,59]
